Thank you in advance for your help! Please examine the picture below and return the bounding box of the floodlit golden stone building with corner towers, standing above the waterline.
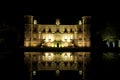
[24,15,90,47]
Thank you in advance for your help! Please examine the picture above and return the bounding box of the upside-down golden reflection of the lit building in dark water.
[24,52,90,79]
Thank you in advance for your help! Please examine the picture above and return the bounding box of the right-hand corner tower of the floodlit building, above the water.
[77,16,91,47]
